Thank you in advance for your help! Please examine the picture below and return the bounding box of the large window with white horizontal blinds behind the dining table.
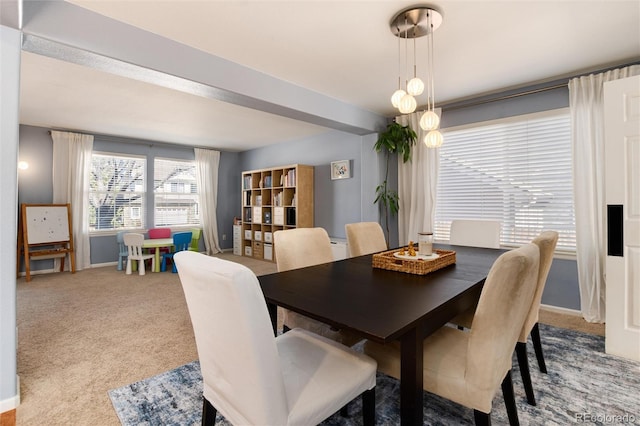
[434,108,576,253]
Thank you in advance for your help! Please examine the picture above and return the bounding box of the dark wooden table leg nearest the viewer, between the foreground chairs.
[400,329,423,426]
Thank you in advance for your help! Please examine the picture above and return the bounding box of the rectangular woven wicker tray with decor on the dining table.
[372,246,456,275]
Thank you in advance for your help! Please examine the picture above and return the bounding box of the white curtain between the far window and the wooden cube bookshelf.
[194,148,222,254]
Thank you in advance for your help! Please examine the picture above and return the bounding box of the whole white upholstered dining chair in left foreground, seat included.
[174,250,376,425]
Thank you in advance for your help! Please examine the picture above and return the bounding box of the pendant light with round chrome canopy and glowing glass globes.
[390,6,442,148]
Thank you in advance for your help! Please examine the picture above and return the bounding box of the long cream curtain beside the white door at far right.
[569,65,640,322]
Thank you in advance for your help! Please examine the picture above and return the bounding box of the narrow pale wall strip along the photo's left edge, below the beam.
[0,25,21,413]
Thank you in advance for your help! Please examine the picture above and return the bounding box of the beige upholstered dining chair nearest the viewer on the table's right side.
[364,243,540,425]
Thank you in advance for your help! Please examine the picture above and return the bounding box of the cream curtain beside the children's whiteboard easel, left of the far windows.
[51,131,93,270]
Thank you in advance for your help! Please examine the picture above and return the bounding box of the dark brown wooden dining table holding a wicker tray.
[258,244,504,425]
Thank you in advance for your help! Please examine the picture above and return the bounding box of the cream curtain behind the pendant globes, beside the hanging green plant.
[396,108,441,245]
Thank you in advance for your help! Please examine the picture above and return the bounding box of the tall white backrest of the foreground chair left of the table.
[174,250,288,425]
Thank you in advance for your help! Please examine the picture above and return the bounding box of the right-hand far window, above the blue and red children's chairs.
[153,159,200,226]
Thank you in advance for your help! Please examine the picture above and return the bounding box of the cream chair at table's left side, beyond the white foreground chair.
[273,228,362,346]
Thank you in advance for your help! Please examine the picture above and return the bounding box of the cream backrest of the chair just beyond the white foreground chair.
[273,228,333,272]
